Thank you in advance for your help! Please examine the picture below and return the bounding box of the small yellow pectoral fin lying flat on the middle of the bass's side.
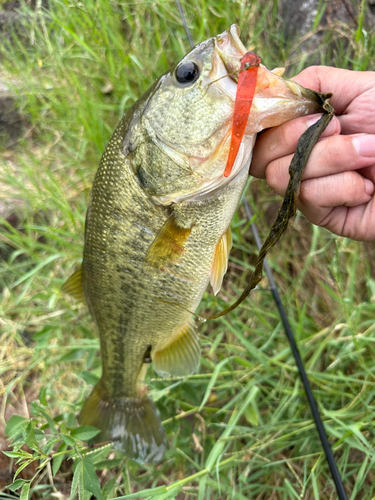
[146,213,191,267]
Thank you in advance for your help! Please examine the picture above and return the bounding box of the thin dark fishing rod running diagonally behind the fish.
[176,0,347,500]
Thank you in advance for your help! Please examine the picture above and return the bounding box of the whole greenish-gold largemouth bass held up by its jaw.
[63,25,320,463]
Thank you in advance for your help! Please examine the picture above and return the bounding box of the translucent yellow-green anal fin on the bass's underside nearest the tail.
[152,323,201,377]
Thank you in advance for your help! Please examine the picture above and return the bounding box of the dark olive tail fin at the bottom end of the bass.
[79,382,166,463]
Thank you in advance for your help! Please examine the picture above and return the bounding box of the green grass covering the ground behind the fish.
[0,0,375,500]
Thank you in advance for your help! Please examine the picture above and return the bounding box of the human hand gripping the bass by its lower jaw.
[250,66,375,241]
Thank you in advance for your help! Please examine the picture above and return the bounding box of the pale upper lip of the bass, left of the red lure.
[215,24,246,83]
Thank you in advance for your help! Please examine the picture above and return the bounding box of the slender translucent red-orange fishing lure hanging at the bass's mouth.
[224,52,261,177]
